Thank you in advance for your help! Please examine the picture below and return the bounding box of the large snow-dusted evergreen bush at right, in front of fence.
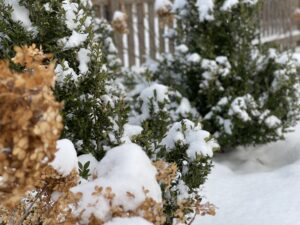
[152,0,299,150]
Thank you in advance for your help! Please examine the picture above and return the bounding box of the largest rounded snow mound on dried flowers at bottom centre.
[71,144,162,223]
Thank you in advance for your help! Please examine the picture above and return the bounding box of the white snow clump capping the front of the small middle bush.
[161,119,218,160]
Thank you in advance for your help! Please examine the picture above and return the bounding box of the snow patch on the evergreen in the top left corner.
[4,0,33,31]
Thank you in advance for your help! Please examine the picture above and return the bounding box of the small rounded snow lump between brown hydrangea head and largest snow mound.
[49,139,78,177]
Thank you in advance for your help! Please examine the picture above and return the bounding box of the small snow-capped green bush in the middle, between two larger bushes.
[124,68,219,224]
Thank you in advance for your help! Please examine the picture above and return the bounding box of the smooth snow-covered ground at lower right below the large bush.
[194,124,300,225]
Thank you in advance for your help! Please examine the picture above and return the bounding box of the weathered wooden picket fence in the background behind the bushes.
[93,0,300,66]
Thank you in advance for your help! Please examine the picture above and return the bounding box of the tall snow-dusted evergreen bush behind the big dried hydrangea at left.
[0,0,126,159]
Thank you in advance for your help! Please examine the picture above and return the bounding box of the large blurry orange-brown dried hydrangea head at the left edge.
[0,44,62,206]
